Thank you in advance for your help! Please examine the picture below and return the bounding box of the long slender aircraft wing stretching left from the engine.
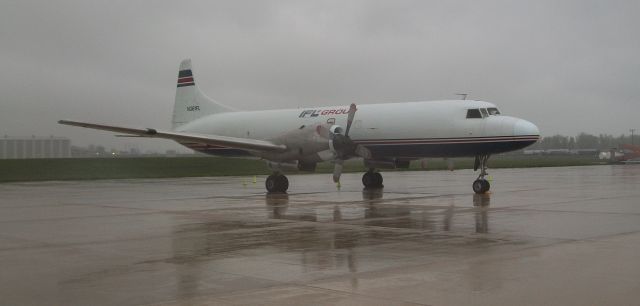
[58,120,287,151]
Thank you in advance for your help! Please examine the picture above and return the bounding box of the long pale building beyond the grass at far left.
[0,136,71,159]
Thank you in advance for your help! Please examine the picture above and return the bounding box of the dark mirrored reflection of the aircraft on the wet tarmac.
[169,189,491,298]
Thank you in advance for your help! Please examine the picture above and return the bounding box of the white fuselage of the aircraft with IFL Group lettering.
[177,100,539,159]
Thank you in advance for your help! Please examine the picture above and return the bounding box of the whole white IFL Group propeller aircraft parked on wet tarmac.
[59,59,540,193]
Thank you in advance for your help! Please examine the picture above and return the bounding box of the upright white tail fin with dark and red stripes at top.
[172,59,234,129]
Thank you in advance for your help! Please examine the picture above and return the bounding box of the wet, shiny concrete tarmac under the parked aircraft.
[0,165,640,305]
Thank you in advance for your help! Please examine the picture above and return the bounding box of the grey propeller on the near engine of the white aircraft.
[332,103,371,183]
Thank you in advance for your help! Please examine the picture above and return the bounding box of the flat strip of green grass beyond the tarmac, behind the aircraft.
[0,155,601,182]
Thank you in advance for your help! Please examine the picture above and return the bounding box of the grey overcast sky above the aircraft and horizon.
[0,0,640,150]
